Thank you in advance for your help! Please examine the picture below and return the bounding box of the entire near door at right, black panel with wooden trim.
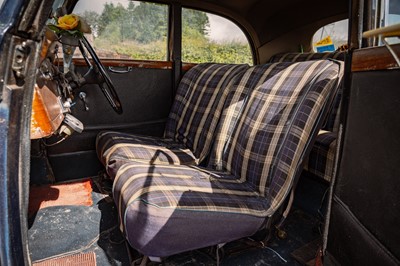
[325,0,400,265]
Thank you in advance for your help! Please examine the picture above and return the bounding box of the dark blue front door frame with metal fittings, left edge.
[0,0,47,265]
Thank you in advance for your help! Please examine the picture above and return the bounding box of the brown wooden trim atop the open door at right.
[351,44,400,72]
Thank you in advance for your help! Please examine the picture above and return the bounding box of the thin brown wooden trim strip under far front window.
[74,58,172,69]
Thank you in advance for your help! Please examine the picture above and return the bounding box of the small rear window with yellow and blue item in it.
[312,19,349,53]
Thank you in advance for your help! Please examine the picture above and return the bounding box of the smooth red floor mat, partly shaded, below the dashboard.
[29,180,93,216]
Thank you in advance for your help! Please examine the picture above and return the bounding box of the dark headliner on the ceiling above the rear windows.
[167,0,349,46]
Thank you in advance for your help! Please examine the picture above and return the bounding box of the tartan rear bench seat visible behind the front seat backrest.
[270,51,346,182]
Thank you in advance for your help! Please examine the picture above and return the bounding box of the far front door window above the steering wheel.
[74,0,168,61]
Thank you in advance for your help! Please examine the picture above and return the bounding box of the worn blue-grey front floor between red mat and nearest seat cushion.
[28,178,130,265]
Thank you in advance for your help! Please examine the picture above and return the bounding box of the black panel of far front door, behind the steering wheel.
[73,63,172,128]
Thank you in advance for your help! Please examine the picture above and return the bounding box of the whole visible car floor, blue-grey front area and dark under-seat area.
[28,171,327,265]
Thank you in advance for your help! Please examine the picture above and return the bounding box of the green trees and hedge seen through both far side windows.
[82,2,253,64]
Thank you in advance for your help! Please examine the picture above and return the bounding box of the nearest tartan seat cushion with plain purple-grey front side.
[113,162,268,257]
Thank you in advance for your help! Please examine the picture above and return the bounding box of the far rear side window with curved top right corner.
[182,8,253,64]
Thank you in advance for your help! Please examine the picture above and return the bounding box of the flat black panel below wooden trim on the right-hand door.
[336,70,400,258]
